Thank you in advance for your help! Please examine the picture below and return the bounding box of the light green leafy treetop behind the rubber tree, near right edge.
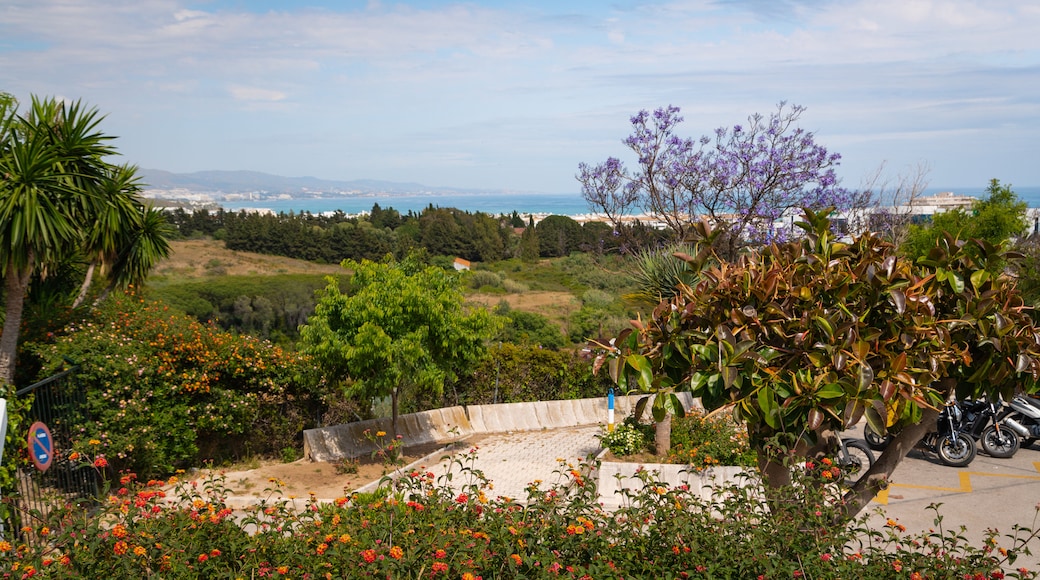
[900,179,1029,268]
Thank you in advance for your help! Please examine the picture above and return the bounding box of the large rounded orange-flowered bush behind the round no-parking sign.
[26,294,319,475]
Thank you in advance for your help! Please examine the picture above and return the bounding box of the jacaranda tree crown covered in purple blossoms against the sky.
[577,103,852,259]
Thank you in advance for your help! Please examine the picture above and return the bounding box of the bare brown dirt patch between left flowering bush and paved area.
[192,445,463,500]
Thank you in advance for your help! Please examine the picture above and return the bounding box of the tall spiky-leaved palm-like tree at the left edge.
[0,97,165,384]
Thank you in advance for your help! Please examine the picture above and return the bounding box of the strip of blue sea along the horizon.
[219,186,1040,216]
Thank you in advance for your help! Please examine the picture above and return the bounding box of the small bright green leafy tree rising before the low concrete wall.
[301,256,499,432]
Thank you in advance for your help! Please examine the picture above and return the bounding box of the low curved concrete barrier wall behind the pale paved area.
[304,393,701,462]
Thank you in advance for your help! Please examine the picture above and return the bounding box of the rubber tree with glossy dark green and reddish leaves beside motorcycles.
[598,209,1040,523]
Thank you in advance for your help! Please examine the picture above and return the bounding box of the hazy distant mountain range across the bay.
[138,168,515,195]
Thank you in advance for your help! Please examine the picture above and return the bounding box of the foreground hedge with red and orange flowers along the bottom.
[0,451,1037,580]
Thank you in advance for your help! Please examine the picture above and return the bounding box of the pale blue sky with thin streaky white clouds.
[0,0,1040,193]
